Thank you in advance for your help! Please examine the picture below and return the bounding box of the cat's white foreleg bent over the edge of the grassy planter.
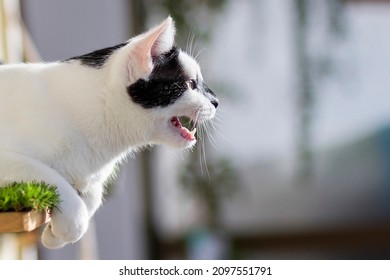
[0,151,89,248]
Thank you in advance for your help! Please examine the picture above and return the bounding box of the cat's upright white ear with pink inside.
[129,17,176,78]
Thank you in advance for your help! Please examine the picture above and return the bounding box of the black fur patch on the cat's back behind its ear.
[67,43,127,69]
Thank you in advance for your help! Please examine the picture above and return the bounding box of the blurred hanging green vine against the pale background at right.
[294,0,344,186]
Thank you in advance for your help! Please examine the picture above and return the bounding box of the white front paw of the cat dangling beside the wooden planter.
[42,204,89,249]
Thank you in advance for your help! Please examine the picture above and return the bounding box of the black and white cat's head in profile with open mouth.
[116,17,218,148]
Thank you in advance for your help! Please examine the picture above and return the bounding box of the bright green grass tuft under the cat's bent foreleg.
[0,182,60,212]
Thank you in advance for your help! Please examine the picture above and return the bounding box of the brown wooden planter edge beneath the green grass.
[0,210,50,232]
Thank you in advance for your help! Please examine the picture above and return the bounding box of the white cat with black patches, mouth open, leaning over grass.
[0,17,218,248]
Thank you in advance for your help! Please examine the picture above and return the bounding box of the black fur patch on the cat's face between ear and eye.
[127,48,189,109]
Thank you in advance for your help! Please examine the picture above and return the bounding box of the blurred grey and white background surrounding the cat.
[0,0,390,259]
